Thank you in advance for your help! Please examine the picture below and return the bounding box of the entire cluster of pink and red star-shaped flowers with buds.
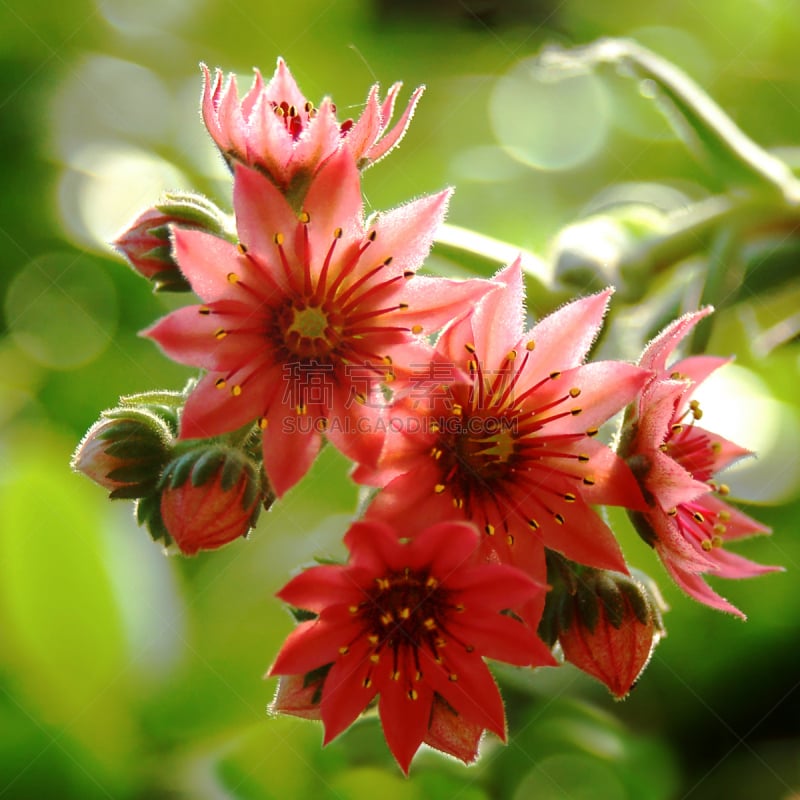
[74,60,770,772]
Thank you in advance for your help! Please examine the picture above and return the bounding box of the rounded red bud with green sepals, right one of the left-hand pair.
[156,444,271,555]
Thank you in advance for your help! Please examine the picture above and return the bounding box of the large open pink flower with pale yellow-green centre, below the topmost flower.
[146,152,491,496]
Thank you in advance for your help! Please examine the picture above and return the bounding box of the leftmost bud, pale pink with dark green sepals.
[72,408,172,499]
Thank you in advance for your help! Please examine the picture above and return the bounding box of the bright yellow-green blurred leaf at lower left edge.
[0,437,132,762]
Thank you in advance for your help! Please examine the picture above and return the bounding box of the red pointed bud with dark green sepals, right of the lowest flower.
[558,569,664,699]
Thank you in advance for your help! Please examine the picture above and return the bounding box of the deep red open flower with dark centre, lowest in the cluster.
[269,522,555,773]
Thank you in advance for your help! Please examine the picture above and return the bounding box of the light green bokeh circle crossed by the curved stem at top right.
[608,26,712,141]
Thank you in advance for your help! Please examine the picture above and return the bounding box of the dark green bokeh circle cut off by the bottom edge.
[514,754,630,800]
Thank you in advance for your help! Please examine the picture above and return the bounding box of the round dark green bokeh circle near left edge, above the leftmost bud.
[5,253,117,369]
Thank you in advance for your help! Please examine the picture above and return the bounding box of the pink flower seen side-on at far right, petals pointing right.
[620,308,779,618]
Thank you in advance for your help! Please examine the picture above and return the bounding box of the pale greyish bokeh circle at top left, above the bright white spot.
[52,54,173,161]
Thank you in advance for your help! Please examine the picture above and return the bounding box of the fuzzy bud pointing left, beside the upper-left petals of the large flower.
[114,193,227,292]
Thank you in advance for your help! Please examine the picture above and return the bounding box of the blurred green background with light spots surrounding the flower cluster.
[0,0,800,800]
